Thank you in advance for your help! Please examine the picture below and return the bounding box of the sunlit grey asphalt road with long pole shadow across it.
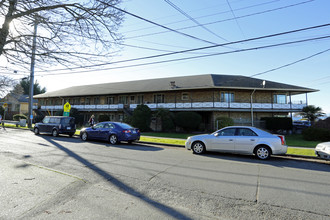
[0,128,330,219]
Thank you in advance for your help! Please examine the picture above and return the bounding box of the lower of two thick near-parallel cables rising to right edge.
[35,35,330,76]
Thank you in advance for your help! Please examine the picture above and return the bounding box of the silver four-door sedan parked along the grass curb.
[185,126,287,160]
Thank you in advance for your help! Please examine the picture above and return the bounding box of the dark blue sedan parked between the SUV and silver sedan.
[80,121,140,144]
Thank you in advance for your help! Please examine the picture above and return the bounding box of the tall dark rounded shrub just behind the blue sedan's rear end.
[131,105,151,131]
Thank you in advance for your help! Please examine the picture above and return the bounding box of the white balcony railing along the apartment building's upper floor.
[41,102,306,110]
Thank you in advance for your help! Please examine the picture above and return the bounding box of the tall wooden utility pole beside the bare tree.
[28,17,38,128]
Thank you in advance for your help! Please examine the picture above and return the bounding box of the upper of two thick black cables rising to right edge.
[32,23,330,72]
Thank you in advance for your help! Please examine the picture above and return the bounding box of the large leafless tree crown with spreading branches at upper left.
[0,0,123,69]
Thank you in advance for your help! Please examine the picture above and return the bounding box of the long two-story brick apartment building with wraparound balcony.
[34,74,317,130]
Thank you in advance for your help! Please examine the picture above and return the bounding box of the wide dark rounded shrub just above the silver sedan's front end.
[174,112,202,131]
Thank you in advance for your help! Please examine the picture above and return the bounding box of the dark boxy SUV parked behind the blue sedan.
[34,116,76,137]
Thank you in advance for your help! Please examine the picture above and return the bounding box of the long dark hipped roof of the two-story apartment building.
[34,74,318,98]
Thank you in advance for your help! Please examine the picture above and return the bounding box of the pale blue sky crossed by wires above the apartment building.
[2,0,330,114]
